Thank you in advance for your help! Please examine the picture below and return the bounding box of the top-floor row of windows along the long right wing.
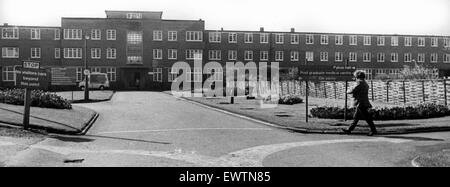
[209,32,450,47]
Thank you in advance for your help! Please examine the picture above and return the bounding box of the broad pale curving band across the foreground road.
[12,138,411,167]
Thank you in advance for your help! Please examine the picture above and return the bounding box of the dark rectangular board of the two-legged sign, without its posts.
[298,65,356,81]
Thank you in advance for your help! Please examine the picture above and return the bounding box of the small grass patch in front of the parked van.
[56,90,114,102]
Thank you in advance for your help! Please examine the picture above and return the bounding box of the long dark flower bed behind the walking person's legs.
[311,103,450,121]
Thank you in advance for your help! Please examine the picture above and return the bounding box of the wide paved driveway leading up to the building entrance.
[0,92,450,167]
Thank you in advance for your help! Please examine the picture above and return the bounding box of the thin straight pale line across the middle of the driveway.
[96,128,274,135]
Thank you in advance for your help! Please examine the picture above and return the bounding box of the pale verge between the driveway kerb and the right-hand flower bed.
[180,95,450,135]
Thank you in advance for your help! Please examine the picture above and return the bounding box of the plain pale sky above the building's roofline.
[0,0,450,35]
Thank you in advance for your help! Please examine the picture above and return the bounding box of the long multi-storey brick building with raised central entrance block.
[0,11,450,89]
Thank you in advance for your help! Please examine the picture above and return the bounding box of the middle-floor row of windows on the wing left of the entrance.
[2,47,117,59]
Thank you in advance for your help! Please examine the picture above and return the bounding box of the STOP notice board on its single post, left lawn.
[16,61,49,129]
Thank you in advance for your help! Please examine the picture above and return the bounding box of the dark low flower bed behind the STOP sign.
[0,89,72,109]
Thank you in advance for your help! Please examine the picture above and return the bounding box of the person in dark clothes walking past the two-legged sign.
[342,71,377,136]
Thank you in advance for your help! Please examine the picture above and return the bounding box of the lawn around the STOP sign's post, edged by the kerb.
[0,103,96,133]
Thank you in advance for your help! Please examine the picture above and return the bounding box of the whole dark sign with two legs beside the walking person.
[299,65,356,123]
